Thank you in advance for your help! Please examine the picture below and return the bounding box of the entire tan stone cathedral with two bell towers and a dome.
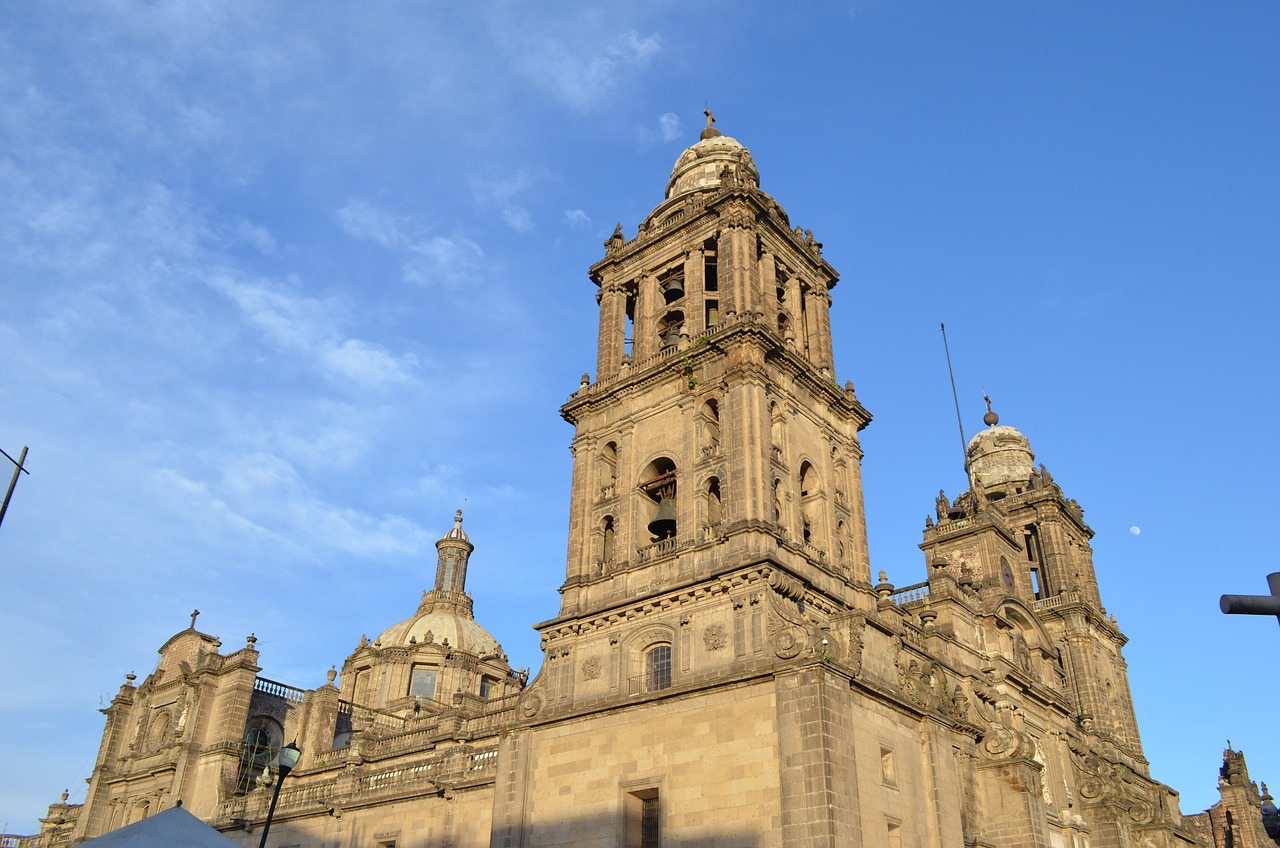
[13,113,1270,848]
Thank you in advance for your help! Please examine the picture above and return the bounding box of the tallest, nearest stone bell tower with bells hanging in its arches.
[527,113,872,699]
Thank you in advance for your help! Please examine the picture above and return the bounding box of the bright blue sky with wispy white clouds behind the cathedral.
[0,0,1280,833]
